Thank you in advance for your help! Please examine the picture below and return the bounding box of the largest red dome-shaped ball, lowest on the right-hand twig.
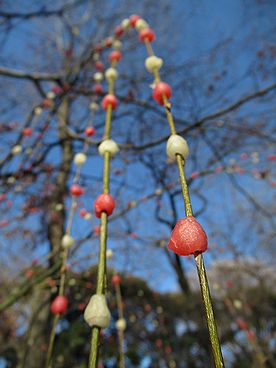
[168,216,208,256]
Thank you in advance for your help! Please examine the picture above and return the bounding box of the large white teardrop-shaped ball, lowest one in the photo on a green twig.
[84,294,111,328]
